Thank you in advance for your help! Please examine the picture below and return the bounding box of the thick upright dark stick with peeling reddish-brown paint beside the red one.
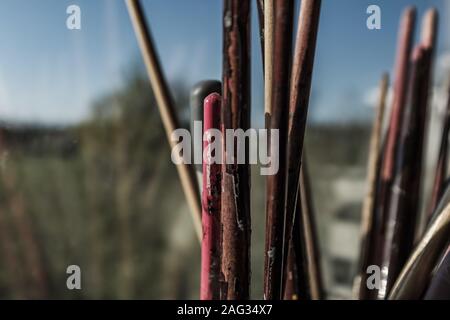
[221,0,251,300]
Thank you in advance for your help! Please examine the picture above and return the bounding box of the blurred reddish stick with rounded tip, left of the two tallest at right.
[370,7,416,297]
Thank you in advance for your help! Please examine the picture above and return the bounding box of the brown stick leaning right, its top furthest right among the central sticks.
[283,0,321,295]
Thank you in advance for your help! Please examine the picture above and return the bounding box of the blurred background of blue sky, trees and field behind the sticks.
[0,0,450,299]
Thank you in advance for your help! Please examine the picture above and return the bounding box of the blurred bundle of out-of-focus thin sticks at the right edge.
[355,7,450,299]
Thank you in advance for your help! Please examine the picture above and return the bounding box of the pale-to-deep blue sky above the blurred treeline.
[0,0,450,125]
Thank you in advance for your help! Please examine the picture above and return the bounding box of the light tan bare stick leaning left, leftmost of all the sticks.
[126,0,202,240]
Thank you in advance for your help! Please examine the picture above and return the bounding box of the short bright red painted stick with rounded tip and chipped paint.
[200,93,222,300]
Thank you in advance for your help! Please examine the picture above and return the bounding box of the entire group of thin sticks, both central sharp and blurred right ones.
[127,0,450,300]
